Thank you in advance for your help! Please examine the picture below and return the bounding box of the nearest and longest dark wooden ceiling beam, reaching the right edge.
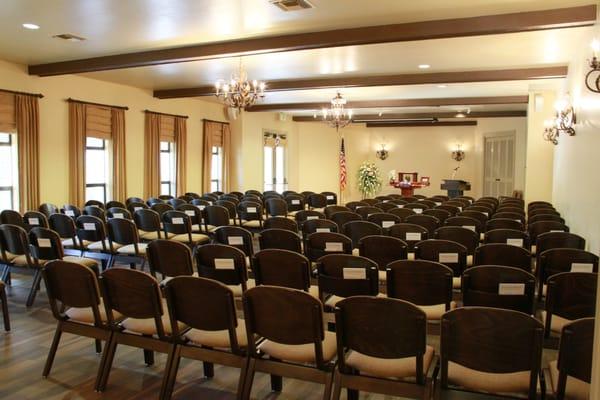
[29,4,596,76]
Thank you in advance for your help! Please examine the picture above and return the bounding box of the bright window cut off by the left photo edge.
[0,133,19,210]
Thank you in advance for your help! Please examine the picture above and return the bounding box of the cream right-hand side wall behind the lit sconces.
[552,26,600,399]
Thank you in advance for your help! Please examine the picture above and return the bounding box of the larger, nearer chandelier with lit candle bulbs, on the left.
[215,59,266,111]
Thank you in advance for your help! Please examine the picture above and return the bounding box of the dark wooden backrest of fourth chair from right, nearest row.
[243,286,325,368]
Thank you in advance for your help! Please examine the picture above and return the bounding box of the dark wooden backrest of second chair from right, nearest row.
[440,307,543,399]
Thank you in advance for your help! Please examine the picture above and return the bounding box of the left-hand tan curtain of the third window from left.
[144,113,160,198]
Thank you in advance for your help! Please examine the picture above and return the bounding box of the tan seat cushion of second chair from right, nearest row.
[448,361,529,394]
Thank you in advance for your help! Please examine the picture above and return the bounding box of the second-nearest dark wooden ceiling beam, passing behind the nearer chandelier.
[154,65,568,99]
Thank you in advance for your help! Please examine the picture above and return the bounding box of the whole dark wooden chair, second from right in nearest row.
[436,307,543,400]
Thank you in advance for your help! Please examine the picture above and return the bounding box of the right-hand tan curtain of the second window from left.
[111,108,127,201]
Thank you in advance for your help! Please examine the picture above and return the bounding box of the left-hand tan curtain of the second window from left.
[69,102,86,207]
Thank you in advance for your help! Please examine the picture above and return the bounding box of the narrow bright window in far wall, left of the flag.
[263,133,287,193]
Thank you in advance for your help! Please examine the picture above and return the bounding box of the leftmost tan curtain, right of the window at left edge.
[15,94,40,211]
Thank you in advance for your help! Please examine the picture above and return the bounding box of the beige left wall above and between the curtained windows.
[0,61,224,205]
